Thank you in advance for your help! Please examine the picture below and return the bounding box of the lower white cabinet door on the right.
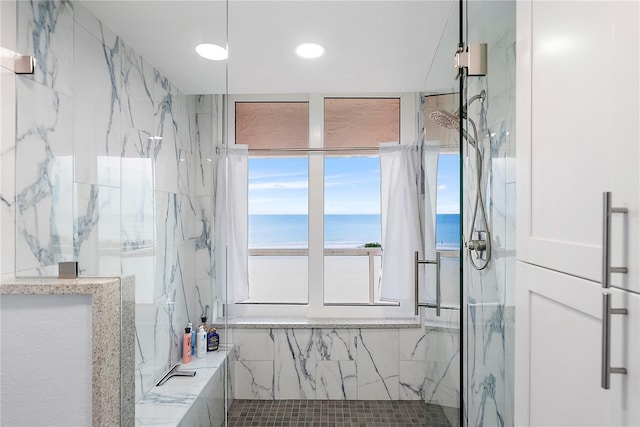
[515,262,640,426]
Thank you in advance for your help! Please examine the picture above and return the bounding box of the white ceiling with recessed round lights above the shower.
[85,0,457,94]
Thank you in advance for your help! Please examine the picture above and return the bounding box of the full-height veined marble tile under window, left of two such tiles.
[274,329,316,399]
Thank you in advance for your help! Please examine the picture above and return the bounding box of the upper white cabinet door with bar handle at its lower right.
[516,1,640,291]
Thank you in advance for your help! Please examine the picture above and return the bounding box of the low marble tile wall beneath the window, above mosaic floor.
[229,327,459,407]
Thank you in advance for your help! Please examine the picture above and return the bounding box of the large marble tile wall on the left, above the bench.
[0,0,218,399]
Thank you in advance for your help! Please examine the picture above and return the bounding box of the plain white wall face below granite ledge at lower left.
[0,295,92,426]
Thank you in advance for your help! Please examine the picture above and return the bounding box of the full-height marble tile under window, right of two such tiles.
[358,329,398,400]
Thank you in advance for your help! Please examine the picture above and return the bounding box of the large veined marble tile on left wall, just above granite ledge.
[15,78,73,274]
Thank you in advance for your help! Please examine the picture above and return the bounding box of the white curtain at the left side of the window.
[223,145,249,303]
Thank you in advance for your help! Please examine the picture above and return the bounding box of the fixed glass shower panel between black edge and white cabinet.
[461,0,516,426]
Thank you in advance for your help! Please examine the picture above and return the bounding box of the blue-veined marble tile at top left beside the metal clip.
[17,0,74,96]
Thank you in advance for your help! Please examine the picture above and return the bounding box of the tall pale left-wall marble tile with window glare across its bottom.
[74,20,121,187]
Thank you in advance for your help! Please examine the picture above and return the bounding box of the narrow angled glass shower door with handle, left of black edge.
[422,1,464,426]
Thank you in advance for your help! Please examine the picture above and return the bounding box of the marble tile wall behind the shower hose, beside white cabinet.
[463,15,516,426]
